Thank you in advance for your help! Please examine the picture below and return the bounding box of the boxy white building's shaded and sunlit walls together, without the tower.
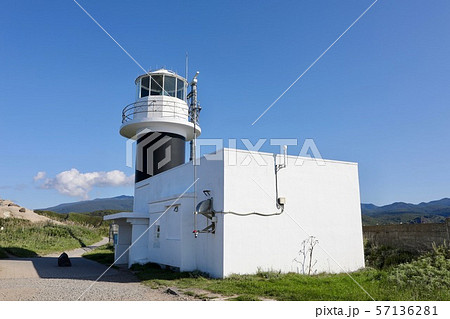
[108,149,364,277]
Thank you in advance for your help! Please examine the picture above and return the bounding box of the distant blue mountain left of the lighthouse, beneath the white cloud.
[39,195,133,214]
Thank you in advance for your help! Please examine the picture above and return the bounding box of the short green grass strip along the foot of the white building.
[135,266,378,300]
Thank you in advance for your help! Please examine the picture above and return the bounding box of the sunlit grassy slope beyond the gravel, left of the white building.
[0,218,105,257]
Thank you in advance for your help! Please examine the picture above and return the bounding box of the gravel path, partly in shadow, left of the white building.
[0,241,191,300]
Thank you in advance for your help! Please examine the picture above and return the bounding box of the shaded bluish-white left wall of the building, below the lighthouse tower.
[130,151,224,277]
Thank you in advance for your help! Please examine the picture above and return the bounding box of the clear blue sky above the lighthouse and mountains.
[0,0,450,208]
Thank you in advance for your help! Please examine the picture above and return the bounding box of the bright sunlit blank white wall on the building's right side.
[224,150,364,276]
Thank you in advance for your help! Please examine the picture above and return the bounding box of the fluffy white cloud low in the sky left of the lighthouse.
[36,168,134,199]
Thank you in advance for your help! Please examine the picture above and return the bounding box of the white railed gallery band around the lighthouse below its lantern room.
[122,101,190,123]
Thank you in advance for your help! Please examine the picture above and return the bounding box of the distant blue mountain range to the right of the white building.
[361,198,450,225]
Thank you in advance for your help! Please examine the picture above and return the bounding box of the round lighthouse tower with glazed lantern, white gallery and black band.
[120,69,201,183]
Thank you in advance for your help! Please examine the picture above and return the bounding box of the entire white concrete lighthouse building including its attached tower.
[105,70,364,278]
